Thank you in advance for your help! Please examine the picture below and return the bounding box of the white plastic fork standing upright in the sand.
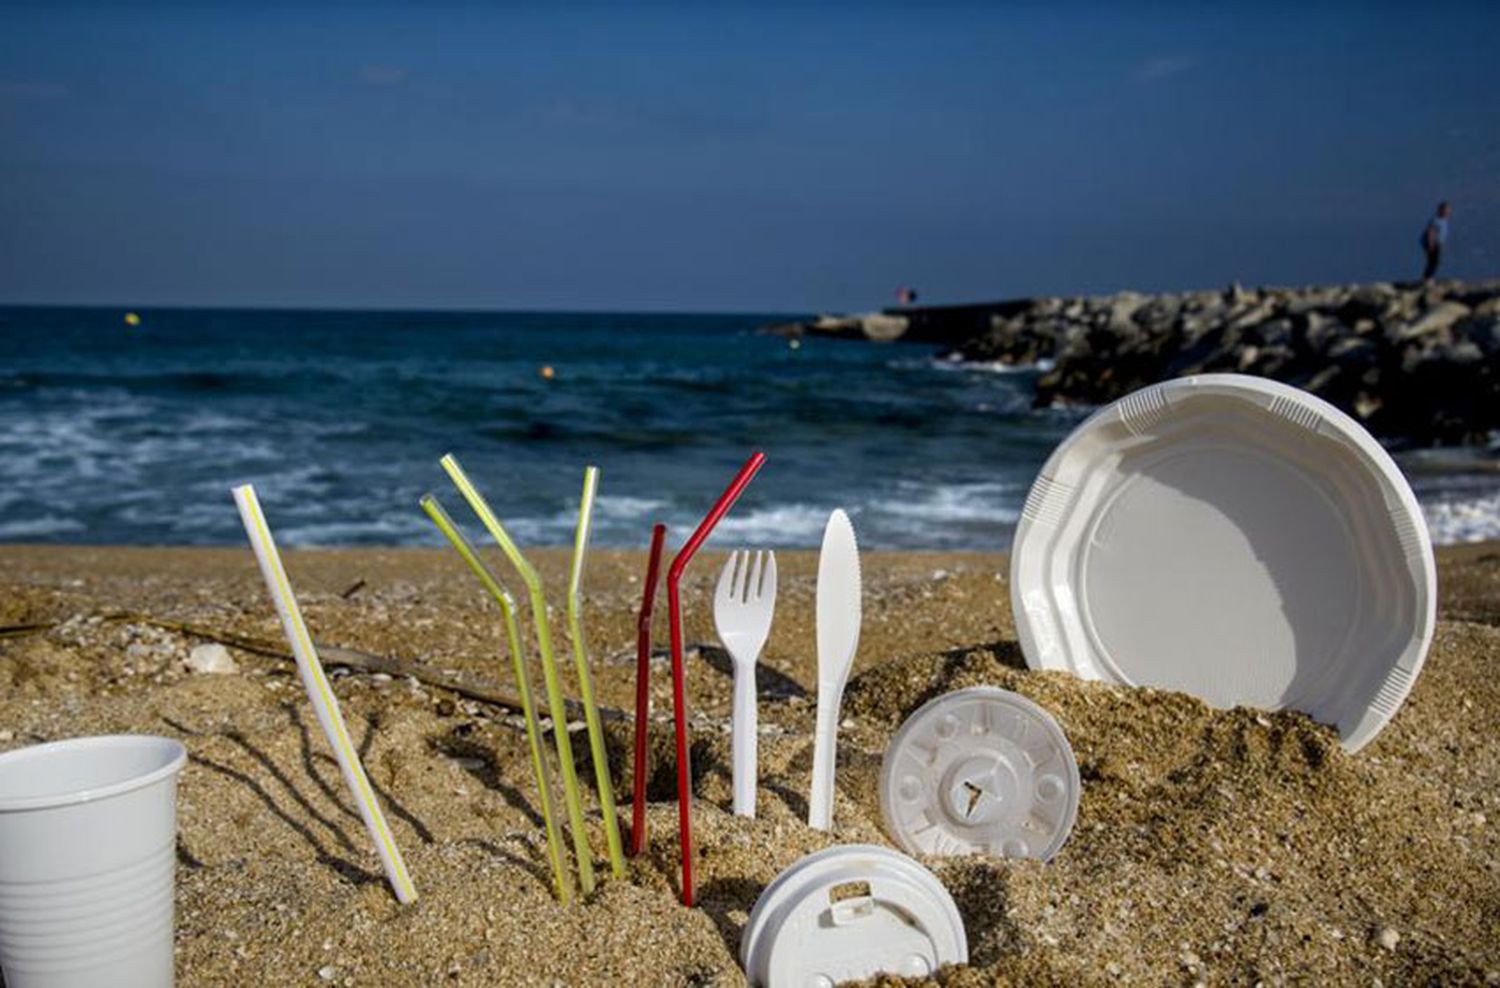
[714,550,776,817]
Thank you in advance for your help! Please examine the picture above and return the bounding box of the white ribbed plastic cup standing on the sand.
[0,735,188,988]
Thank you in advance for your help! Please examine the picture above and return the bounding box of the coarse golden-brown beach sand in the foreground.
[0,543,1500,987]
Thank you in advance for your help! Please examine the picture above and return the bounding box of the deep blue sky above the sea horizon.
[0,4,1500,312]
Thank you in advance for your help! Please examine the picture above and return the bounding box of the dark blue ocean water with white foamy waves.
[0,307,1500,550]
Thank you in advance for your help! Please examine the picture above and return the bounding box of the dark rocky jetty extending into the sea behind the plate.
[774,279,1500,445]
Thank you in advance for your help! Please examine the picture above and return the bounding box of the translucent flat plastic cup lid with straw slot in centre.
[881,687,1082,861]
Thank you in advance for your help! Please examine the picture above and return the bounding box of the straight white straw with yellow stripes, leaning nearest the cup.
[234,484,417,904]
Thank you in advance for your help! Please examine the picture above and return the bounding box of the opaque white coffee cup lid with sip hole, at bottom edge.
[740,844,969,988]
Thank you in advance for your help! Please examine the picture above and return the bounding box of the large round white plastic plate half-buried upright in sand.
[1011,375,1437,751]
